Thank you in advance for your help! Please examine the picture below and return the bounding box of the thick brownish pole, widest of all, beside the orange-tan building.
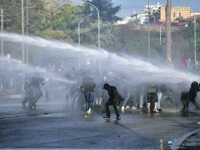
[166,0,172,60]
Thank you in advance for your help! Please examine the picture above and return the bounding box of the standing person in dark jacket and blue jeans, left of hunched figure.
[80,75,96,114]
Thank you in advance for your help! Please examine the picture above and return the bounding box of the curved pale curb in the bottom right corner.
[171,129,200,150]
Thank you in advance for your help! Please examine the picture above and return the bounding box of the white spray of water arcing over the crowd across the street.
[0,33,200,110]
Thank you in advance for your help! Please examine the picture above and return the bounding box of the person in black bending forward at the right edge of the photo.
[181,81,200,114]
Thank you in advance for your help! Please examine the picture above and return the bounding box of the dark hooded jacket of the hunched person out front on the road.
[104,83,124,104]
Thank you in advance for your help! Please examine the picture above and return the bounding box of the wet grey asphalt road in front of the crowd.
[0,94,200,149]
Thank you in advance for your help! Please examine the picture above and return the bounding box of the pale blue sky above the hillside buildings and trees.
[75,0,200,17]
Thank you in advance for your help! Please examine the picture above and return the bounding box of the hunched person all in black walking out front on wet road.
[103,83,124,120]
